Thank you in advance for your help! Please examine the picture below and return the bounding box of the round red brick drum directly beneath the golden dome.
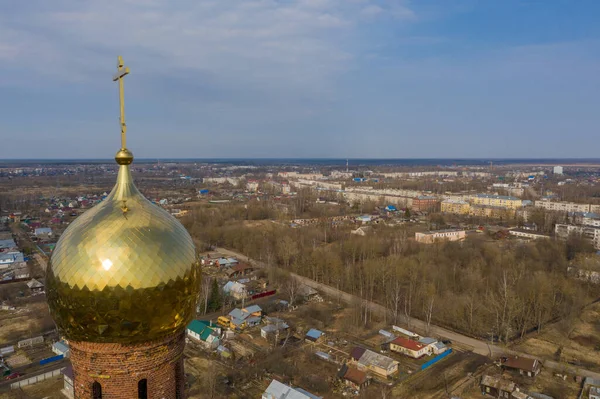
[69,331,185,399]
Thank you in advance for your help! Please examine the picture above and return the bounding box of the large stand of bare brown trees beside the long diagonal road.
[184,204,598,342]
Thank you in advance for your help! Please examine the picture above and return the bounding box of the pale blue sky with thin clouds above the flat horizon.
[0,0,600,158]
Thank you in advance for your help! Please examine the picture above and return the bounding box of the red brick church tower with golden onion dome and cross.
[46,57,200,399]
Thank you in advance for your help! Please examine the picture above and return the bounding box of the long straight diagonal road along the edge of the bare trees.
[217,248,600,379]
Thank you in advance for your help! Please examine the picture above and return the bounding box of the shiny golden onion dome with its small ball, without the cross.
[46,153,200,343]
